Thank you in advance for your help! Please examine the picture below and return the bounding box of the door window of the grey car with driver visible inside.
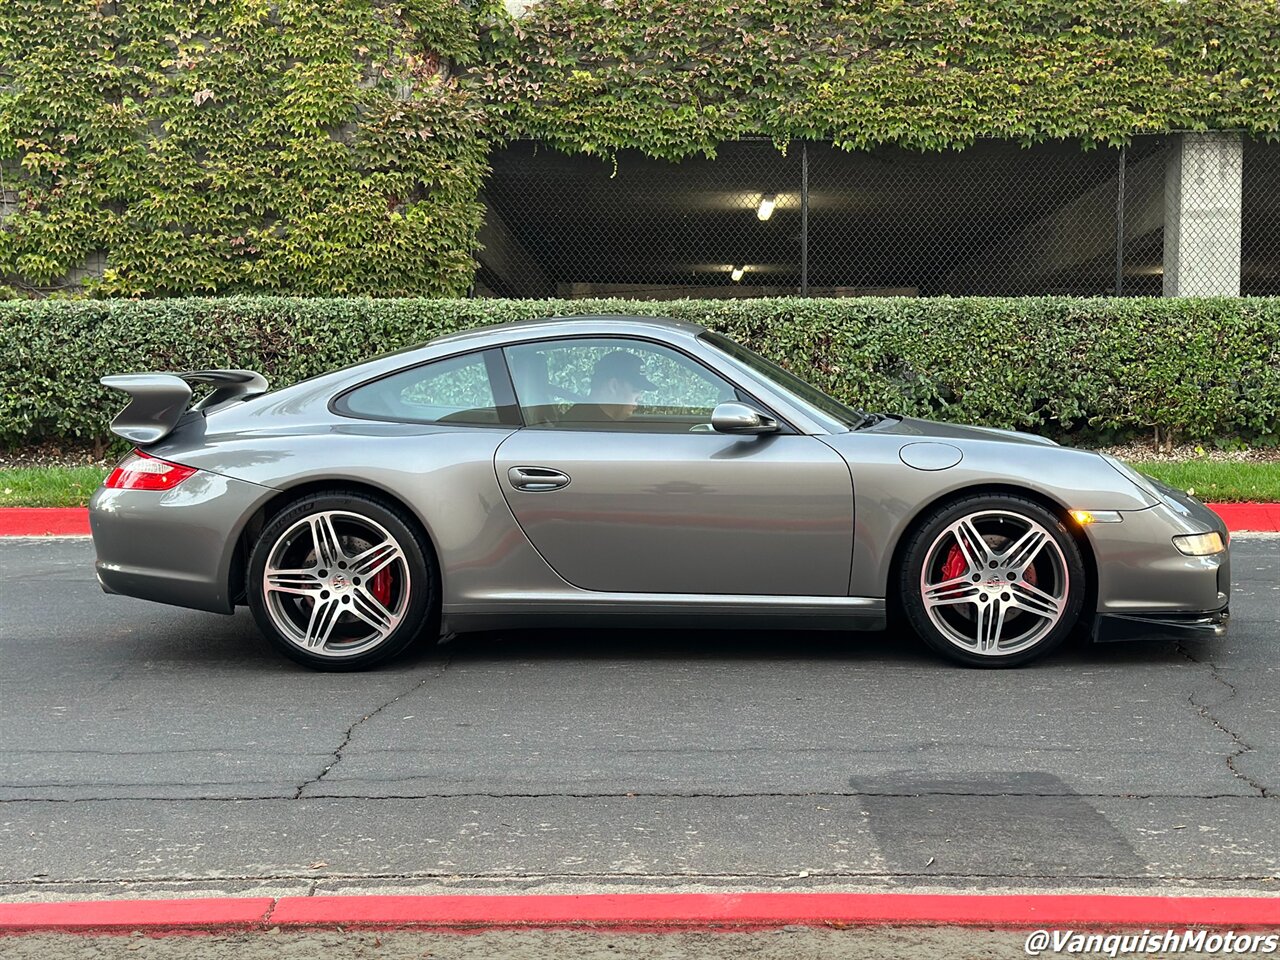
[507,338,736,433]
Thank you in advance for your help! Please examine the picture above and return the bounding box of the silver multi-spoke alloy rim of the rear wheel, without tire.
[261,511,412,658]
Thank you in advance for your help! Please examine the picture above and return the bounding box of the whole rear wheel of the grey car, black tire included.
[248,492,439,669]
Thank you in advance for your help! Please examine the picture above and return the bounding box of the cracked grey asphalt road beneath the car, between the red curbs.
[0,539,1280,900]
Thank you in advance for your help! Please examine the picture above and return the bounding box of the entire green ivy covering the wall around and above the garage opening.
[0,0,1280,296]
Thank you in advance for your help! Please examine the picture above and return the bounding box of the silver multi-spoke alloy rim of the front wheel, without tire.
[920,509,1070,657]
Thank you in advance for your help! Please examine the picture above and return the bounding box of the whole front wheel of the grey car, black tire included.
[899,494,1085,667]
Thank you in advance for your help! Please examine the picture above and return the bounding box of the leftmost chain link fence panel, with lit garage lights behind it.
[477,141,800,298]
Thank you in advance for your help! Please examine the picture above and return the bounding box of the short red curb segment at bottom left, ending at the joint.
[0,897,275,934]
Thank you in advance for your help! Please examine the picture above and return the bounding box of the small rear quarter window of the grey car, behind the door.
[337,352,520,425]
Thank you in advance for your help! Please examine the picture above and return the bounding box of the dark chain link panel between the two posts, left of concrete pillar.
[809,141,1117,296]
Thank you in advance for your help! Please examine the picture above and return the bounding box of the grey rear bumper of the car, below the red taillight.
[88,470,276,613]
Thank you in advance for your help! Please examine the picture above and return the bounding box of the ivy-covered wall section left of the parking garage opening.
[0,0,486,296]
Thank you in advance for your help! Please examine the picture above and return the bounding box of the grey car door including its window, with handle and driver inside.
[494,338,854,596]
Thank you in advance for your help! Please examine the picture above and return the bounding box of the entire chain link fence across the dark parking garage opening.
[476,133,1280,300]
